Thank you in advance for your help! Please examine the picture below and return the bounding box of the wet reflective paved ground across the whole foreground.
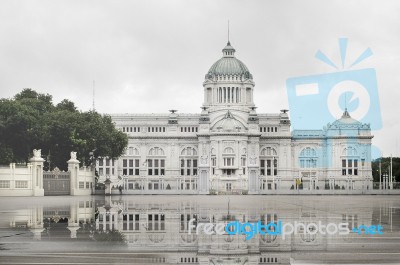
[0,193,400,264]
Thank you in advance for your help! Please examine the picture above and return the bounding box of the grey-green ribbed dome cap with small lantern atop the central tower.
[206,42,253,79]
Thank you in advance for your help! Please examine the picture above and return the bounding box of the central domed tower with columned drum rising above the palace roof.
[203,41,254,111]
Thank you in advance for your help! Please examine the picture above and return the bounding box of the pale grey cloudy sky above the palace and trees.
[0,0,400,156]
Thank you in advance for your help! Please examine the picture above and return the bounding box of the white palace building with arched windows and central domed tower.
[96,42,373,194]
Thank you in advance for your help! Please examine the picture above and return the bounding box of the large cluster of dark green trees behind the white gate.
[0,88,128,170]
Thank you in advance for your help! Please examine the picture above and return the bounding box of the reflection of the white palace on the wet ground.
[92,197,390,264]
